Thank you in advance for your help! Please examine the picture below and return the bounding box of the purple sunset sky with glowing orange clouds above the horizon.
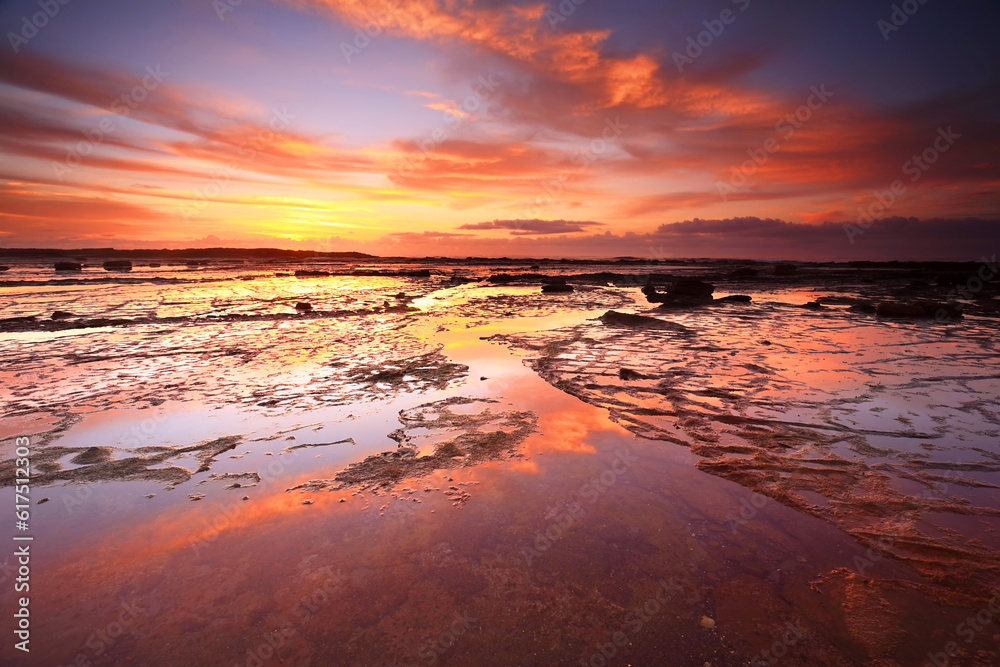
[0,0,1000,261]
